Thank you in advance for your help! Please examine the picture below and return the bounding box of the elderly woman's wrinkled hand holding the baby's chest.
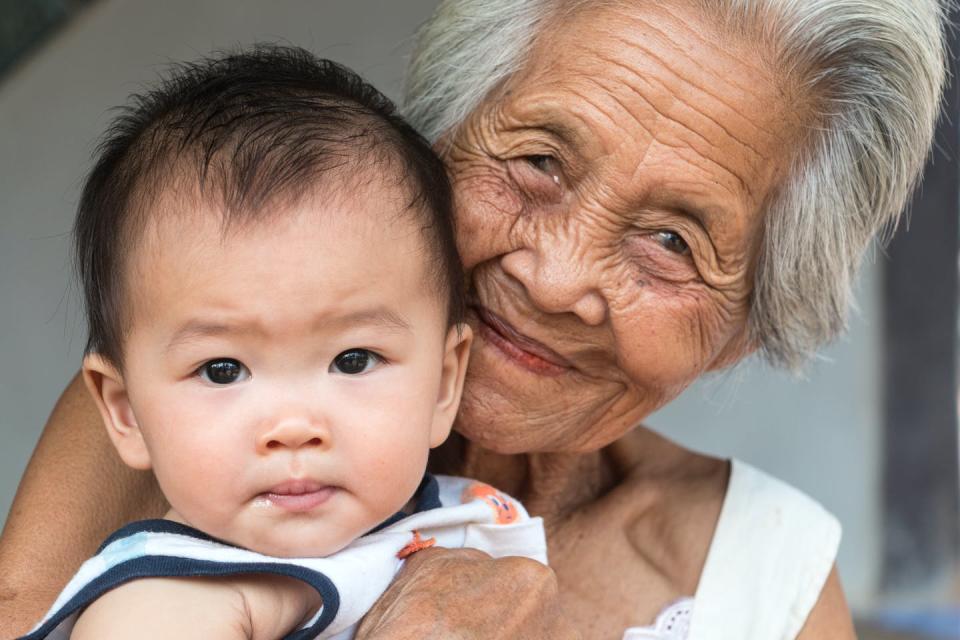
[356,548,579,640]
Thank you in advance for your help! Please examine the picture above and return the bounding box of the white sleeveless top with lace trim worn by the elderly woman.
[623,460,840,640]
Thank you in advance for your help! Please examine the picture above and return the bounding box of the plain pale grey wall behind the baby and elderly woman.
[0,0,880,605]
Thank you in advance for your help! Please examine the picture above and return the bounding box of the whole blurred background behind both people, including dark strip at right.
[0,0,960,639]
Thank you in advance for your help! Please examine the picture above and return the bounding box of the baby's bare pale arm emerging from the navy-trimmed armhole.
[71,574,321,640]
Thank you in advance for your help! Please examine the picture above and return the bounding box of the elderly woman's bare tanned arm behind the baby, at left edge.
[0,376,167,638]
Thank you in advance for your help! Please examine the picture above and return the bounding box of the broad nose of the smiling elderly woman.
[500,241,607,326]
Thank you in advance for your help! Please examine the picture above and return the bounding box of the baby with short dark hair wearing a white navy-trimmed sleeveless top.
[25,47,546,639]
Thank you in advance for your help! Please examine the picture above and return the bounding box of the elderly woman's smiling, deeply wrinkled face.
[447,3,800,453]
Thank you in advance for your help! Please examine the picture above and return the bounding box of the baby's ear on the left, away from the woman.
[83,353,150,470]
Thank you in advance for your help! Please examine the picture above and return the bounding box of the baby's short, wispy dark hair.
[74,45,464,368]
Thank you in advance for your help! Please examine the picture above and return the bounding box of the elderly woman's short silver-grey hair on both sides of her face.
[404,0,948,371]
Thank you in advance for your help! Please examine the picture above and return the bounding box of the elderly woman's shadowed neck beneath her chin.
[431,433,619,526]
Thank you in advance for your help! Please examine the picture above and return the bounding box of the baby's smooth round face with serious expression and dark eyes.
[88,180,467,556]
